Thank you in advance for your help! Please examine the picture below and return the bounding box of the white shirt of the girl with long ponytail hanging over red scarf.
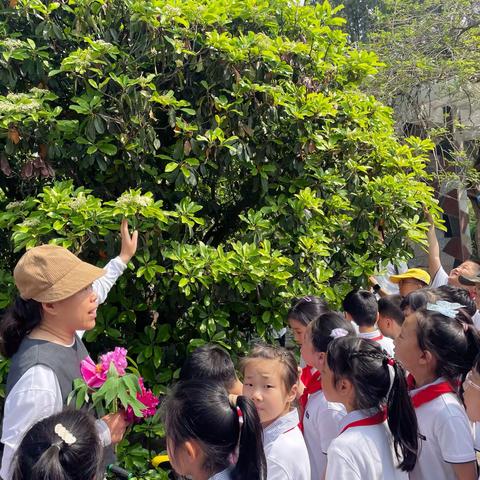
[325,410,406,480]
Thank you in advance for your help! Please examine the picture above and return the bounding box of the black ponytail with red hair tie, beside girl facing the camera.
[231,395,267,480]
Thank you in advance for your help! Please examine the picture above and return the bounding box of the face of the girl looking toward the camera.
[243,358,297,428]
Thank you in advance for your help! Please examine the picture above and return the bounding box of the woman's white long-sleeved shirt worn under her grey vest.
[0,257,127,480]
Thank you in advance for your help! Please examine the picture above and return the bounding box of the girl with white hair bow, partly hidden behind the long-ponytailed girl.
[300,312,356,479]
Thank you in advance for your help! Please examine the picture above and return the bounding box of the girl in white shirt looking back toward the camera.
[242,345,311,480]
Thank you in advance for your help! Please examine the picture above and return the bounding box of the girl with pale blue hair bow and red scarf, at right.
[395,300,480,480]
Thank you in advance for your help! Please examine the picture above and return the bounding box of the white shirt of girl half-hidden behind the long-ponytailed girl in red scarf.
[303,390,347,480]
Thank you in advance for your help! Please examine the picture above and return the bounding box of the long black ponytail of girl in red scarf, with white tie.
[383,356,418,472]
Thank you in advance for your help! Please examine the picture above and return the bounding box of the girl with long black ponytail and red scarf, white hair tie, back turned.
[322,336,420,480]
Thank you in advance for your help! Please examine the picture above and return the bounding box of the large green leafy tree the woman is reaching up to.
[0,0,437,468]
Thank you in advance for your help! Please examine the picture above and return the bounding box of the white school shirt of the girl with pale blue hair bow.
[410,377,476,480]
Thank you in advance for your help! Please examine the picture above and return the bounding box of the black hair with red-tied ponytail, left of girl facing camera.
[162,380,267,480]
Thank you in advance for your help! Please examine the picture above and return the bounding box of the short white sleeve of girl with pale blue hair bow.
[436,414,476,463]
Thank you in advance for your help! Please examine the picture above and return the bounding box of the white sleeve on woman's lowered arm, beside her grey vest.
[0,365,63,480]
